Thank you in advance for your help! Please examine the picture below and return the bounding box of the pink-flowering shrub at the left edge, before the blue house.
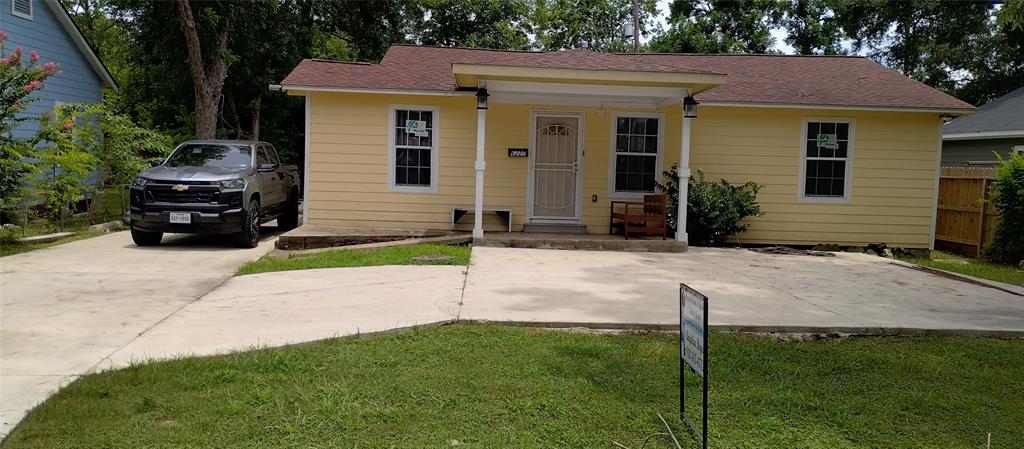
[0,31,59,209]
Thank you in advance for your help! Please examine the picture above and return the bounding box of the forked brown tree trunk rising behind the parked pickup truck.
[177,0,231,138]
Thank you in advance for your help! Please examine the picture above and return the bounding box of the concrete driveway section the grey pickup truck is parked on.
[0,228,274,436]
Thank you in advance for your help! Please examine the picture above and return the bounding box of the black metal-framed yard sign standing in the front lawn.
[679,284,708,449]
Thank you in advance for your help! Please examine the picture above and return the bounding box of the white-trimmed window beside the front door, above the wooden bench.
[612,114,664,194]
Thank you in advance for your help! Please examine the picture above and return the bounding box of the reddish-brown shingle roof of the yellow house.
[282,45,974,110]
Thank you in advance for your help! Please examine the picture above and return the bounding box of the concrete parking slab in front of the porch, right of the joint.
[460,248,1024,331]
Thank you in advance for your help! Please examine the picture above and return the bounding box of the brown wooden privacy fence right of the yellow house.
[935,166,998,256]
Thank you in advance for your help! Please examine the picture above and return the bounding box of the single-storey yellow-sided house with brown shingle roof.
[282,45,974,248]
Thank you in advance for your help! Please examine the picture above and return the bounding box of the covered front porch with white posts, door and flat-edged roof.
[452,65,723,243]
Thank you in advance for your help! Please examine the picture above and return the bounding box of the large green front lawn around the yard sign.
[7,324,1024,449]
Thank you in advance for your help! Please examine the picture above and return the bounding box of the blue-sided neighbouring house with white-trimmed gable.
[0,0,118,137]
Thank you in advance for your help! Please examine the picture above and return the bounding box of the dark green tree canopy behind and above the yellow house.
[56,0,1024,160]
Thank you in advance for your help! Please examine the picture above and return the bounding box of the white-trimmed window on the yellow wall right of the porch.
[801,119,853,200]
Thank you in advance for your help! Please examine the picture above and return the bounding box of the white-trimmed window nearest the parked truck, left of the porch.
[388,107,437,192]
